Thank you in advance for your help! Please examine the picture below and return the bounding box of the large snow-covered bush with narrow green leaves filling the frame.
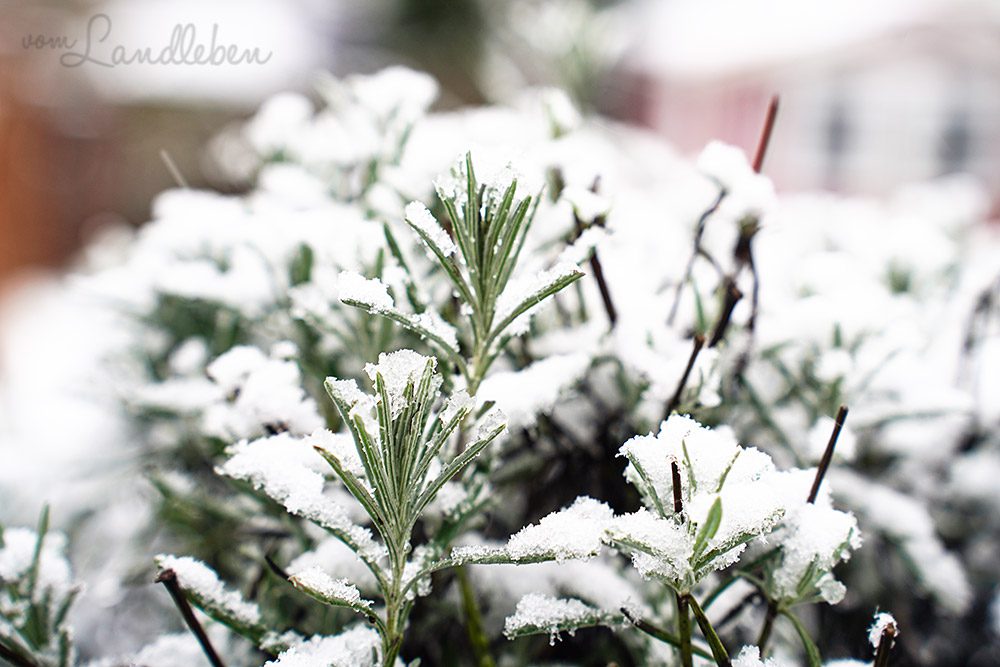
[0,68,1000,667]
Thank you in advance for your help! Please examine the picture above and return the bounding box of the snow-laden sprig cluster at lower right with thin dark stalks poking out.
[438,415,860,667]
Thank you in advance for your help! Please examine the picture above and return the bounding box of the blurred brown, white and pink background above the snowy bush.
[0,0,1000,298]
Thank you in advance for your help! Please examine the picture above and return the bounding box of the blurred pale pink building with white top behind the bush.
[622,0,1000,209]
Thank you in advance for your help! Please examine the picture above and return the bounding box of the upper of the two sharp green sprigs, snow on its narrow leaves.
[341,153,583,395]
